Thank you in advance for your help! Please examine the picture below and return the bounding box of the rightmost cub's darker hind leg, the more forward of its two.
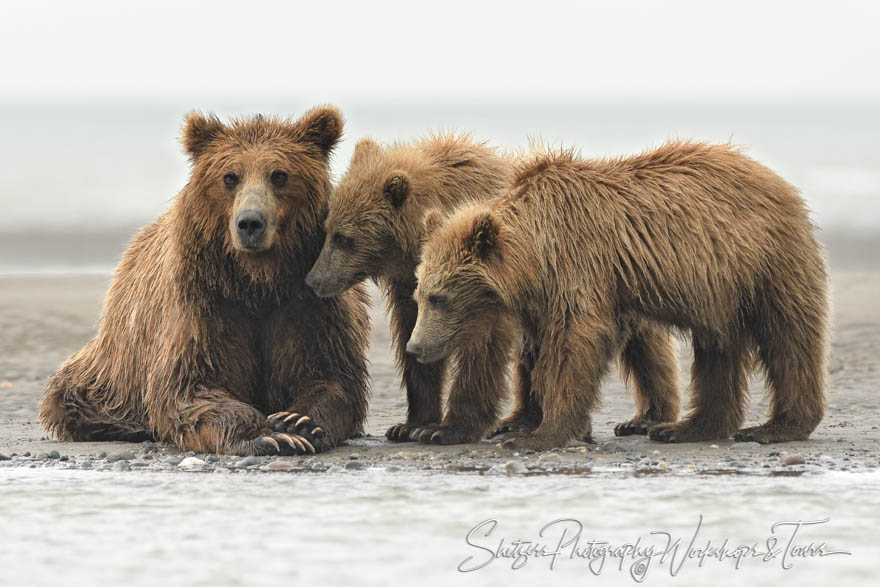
[648,336,749,442]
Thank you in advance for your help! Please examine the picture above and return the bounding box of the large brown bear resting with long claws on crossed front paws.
[40,107,369,455]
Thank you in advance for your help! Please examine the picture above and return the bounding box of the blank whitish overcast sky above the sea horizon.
[0,0,880,103]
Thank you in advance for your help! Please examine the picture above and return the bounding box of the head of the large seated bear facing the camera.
[180,106,343,290]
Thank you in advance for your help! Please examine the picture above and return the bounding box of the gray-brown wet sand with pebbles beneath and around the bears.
[0,271,880,474]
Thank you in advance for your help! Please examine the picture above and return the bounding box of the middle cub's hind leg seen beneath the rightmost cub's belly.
[614,322,681,436]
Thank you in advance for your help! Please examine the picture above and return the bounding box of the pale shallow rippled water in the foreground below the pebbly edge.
[0,468,880,586]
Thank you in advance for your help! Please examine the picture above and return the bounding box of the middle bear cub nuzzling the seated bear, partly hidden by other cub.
[306,135,512,443]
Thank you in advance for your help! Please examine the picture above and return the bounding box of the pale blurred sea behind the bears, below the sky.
[0,101,880,270]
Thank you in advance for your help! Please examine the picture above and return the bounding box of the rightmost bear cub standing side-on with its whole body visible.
[411,141,828,450]
